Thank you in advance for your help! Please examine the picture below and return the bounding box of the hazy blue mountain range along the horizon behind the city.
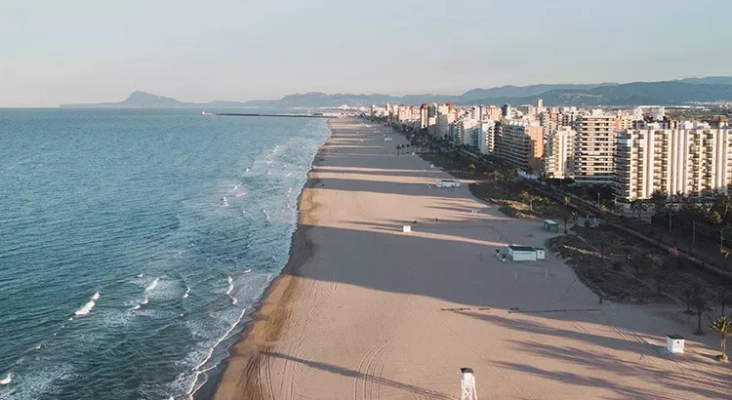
[62,76,732,110]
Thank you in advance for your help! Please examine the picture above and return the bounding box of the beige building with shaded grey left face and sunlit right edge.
[497,120,544,173]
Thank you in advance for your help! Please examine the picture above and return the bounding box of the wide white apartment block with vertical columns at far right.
[615,122,732,202]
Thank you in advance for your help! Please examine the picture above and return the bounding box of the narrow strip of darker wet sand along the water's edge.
[211,121,333,400]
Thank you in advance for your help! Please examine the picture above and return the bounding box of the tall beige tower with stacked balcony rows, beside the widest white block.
[573,110,616,185]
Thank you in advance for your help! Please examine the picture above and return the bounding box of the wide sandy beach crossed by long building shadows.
[214,119,732,400]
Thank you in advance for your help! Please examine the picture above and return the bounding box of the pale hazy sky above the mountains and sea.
[0,0,732,107]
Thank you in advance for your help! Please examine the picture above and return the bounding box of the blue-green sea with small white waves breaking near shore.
[0,109,330,400]
